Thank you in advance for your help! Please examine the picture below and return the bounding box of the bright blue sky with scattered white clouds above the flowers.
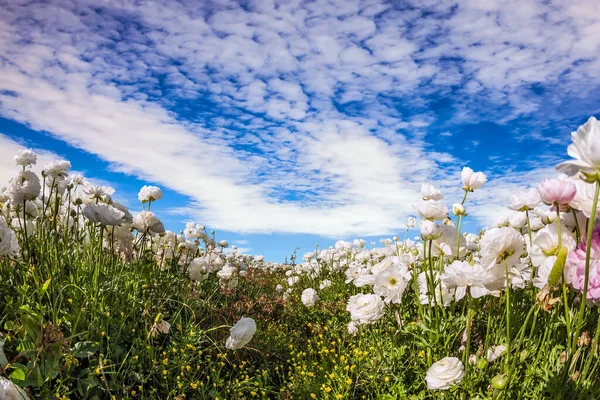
[0,0,600,261]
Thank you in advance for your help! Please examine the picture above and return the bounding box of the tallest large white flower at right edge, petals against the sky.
[556,117,600,176]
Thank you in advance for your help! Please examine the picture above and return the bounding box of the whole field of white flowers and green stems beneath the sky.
[0,118,600,400]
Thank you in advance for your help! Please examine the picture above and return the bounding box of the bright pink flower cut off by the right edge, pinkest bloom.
[567,226,600,305]
